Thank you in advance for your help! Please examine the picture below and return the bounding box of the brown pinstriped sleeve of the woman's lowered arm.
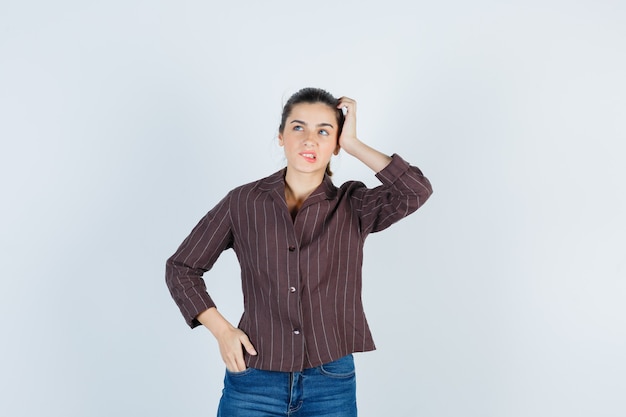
[165,194,233,328]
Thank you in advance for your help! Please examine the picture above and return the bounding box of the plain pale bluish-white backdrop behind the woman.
[0,0,626,417]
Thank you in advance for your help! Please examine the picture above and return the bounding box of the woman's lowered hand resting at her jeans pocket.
[196,307,257,372]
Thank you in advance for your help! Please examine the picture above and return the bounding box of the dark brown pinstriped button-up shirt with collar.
[166,155,432,372]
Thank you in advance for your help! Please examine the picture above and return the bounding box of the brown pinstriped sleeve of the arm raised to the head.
[354,154,433,235]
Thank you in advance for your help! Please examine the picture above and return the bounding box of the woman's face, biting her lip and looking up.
[278,103,339,174]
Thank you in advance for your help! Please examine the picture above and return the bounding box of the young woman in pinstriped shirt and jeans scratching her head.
[166,88,432,417]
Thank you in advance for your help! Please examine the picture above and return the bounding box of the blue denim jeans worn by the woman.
[217,355,357,417]
